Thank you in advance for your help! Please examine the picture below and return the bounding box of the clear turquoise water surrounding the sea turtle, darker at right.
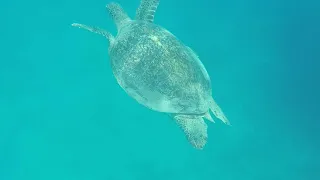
[0,0,320,180]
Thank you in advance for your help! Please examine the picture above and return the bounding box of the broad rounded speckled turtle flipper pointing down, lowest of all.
[173,114,208,149]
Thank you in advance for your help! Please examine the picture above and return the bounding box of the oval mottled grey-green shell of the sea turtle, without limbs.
[109,21,211,114]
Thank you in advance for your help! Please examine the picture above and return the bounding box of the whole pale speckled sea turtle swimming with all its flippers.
[72,0,229,149]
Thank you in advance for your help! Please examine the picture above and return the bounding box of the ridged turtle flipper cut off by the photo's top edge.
[136,0,160,23]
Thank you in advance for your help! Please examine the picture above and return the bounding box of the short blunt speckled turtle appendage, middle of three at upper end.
[107,2,131,31]
